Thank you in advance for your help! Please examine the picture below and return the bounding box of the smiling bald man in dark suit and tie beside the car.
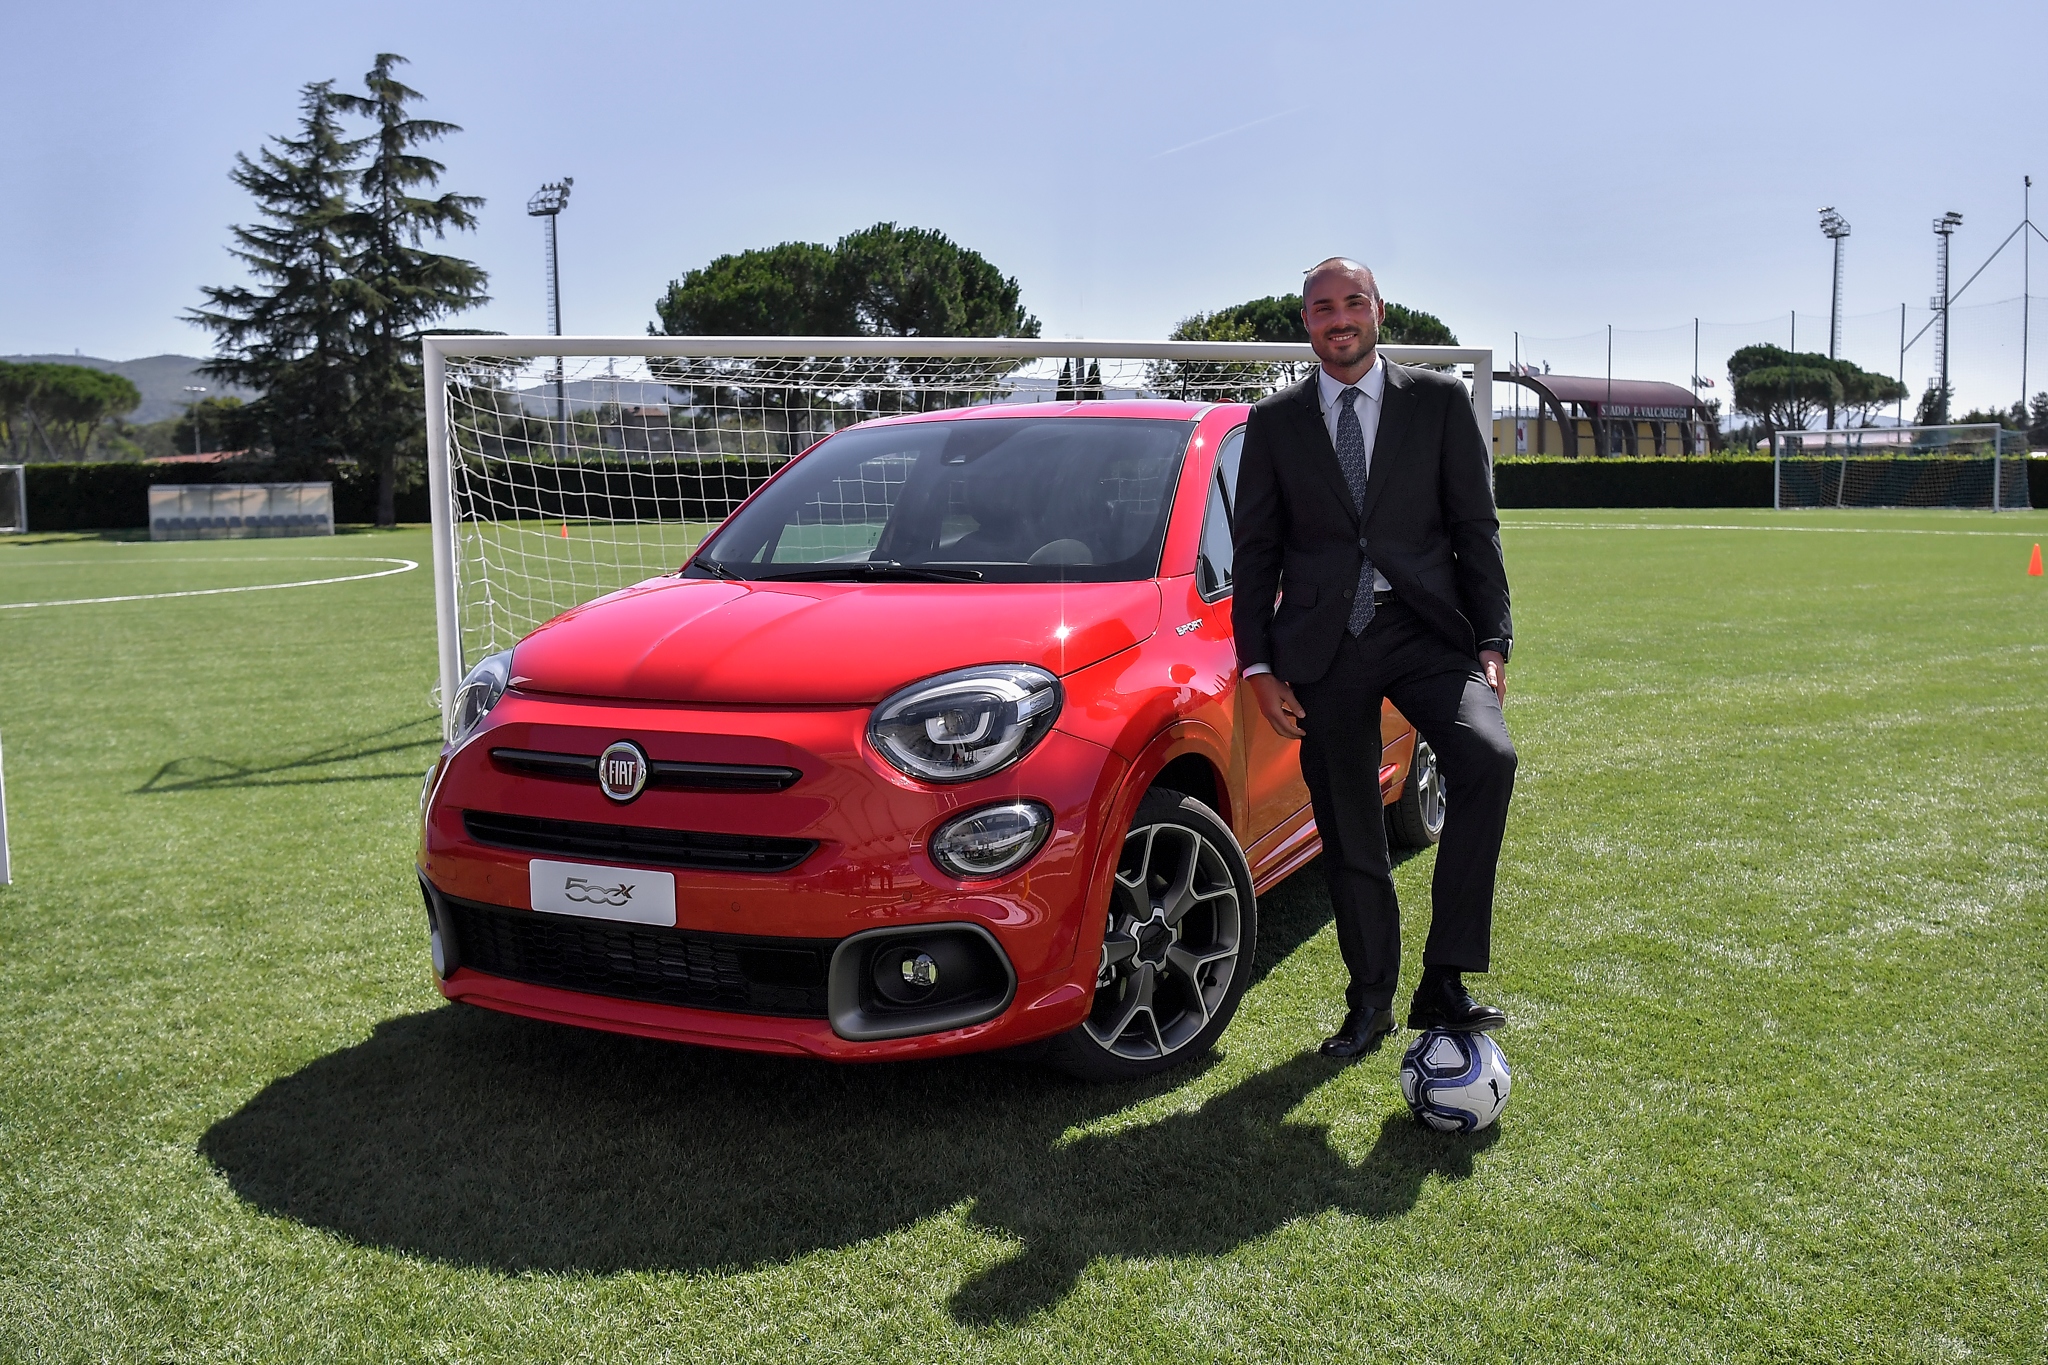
[1231,258,1516,1058]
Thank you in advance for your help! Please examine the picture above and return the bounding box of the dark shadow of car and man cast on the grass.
[199,855,1493,1322]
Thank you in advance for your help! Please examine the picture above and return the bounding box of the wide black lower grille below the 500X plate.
[440,896,836,1019]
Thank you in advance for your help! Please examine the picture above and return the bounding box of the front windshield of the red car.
[690,417,1194,583]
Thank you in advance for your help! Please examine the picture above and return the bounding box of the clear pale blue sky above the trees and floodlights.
[0,0,2048,417]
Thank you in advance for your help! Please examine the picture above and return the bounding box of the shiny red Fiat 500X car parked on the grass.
[420,399,1444,1078]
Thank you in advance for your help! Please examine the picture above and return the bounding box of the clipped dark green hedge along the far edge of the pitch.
[29,458,2048,530]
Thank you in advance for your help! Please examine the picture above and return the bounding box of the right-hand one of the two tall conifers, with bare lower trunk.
[336,53,489,526]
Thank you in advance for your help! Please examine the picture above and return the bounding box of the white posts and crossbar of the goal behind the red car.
[420,334,1493,733]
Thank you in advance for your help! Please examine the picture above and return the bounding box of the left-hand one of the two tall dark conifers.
[186,80,362,475]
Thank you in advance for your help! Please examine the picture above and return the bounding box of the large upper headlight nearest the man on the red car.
[868,663,1061,782]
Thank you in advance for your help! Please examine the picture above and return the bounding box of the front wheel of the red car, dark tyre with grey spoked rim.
[1047,788,1260,1081]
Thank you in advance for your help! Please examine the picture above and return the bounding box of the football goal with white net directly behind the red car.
[424,334,1493,732]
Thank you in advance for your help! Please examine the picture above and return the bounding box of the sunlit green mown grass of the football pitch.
[0,512,2048,1361]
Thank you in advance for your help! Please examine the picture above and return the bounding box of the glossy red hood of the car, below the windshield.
[512,579,1159,706]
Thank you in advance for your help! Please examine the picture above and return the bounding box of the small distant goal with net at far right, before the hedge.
[1772,424,2032,512]
